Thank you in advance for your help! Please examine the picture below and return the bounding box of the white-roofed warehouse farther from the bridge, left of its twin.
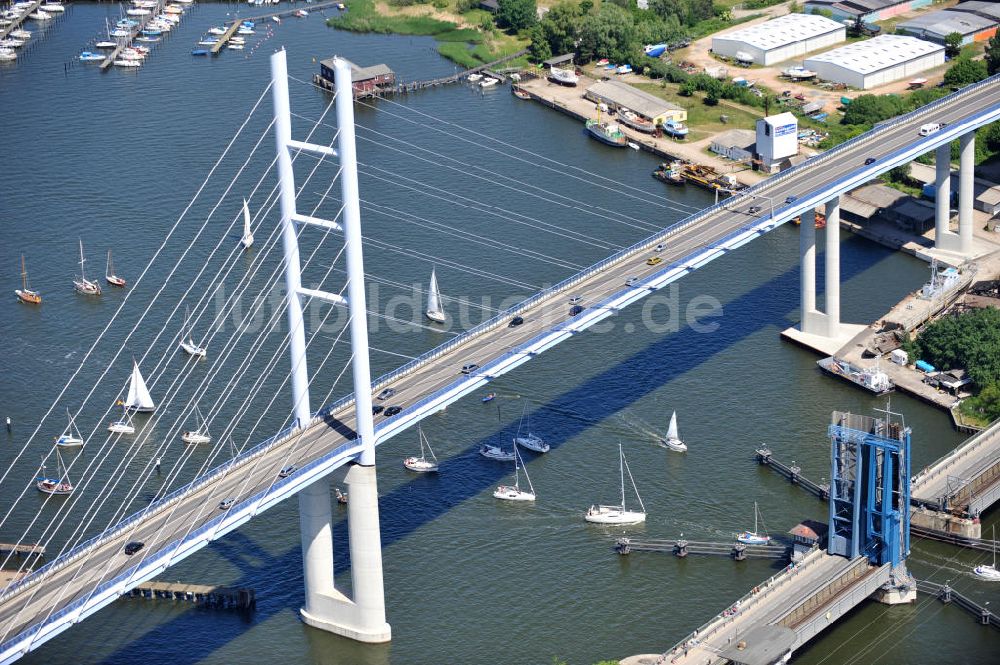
[712,14,847,65]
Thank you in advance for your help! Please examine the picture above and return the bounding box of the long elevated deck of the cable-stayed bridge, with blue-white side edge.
[0,72,1000,663]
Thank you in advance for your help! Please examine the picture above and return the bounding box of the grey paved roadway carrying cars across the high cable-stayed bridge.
[0,84,1000,642]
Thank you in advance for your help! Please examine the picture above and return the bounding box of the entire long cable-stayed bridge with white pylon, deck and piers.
[0,53,1000,662]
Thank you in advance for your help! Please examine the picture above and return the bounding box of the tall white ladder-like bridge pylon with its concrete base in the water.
[271,50,392,642]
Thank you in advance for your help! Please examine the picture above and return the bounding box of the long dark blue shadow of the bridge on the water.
[90,237,892,665]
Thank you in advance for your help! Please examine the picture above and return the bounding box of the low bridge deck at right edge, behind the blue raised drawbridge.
[910,421,1000,514]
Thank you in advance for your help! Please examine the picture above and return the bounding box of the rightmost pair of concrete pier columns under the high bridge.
[934,132,976,256]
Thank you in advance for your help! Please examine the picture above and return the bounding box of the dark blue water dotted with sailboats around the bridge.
[0,5,996,665]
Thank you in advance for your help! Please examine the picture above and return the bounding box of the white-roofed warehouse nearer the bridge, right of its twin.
[802,35,944,90]
